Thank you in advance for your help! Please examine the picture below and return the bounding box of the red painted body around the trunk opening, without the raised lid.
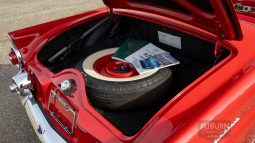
[6,3,255,143]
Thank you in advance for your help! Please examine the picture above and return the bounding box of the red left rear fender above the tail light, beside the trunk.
[8,8,108,68]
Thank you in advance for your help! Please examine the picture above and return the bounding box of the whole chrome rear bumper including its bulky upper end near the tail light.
[10,71,66,143]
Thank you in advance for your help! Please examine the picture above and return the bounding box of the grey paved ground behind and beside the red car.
[0,0,104,143]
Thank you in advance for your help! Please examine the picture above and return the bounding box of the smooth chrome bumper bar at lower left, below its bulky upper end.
[19,92,66,143]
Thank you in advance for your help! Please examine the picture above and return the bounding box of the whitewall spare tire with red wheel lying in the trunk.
[82,48,172,109]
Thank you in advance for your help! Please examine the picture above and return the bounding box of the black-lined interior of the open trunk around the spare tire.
[38,16,230,136]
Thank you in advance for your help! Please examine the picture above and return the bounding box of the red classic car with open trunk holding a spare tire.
[6,0,255,143]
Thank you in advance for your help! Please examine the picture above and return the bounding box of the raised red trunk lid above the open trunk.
[103,0,242,40]
